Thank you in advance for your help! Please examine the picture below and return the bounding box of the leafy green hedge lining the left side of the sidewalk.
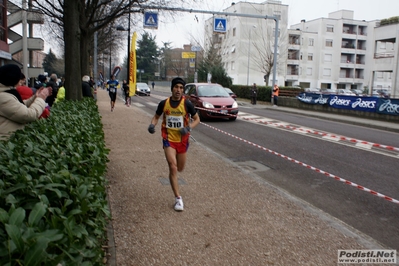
[0,98,110,265]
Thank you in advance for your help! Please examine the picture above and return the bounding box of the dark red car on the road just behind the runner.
[184,83,238,121]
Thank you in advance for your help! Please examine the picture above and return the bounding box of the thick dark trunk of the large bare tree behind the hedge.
[63,0,82,100]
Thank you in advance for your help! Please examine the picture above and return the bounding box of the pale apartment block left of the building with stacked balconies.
[204,0,288,85]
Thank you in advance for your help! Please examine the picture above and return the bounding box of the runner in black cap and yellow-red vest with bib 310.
[148,77,200,211]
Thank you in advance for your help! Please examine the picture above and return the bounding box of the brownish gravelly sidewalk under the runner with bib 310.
[97,90,388,266]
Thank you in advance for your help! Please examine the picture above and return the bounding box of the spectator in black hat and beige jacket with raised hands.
[0,64,51,139]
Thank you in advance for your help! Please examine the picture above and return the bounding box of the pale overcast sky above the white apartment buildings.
[147,0,399,48]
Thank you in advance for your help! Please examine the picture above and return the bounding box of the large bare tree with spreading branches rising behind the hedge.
[34,0,202,99]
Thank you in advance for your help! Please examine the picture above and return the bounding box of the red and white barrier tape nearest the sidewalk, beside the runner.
[201,122,399,204]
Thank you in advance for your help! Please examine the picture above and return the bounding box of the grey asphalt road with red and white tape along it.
[128,92,399,250]
